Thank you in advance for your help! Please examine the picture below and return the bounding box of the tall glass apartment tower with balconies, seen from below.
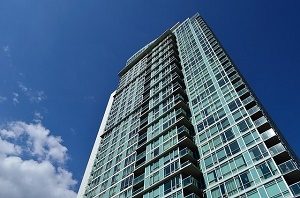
[78,14,300,198]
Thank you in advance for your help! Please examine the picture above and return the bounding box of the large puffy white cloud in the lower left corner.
[0,121,76,198]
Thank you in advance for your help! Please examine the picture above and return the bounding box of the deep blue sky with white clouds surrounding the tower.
[0,0,300,198]
